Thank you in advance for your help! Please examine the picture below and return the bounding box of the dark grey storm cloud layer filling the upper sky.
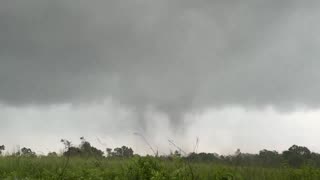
[0,0,320,113]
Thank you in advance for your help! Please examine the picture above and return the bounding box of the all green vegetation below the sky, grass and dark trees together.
[0,138,320,180]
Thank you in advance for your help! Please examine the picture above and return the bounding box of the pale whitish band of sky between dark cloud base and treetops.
[0,100,320,154]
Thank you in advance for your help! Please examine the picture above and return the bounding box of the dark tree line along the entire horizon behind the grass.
[0,137,320,168]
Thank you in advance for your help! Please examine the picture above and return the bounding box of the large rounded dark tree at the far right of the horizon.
[282,145,311,168]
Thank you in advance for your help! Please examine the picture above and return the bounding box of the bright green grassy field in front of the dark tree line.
[0,156,320,180]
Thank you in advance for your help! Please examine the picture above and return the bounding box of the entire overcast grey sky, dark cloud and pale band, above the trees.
[0,0,320,153]
